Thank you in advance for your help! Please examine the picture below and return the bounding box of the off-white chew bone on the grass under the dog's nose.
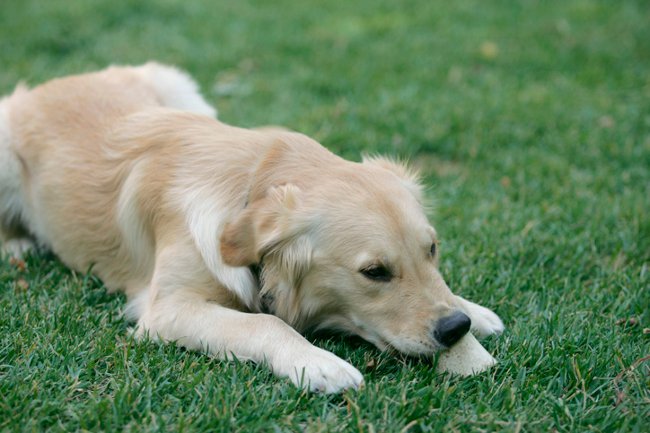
[437,334,497,376]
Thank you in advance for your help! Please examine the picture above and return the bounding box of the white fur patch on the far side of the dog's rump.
[135,62,217,118]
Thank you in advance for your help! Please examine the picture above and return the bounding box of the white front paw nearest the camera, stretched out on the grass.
[273,346,363,394]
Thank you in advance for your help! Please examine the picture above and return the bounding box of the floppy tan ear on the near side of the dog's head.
[221,184,303,266]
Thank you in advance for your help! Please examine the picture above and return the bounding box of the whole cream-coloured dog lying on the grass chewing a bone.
[0,63,503,392]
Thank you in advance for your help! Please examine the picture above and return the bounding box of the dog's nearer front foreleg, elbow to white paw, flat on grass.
[138,290,363,393]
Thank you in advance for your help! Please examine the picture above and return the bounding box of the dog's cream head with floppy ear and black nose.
[221,147,470,355]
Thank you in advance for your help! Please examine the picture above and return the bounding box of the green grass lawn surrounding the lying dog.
[0,0,650,432]
